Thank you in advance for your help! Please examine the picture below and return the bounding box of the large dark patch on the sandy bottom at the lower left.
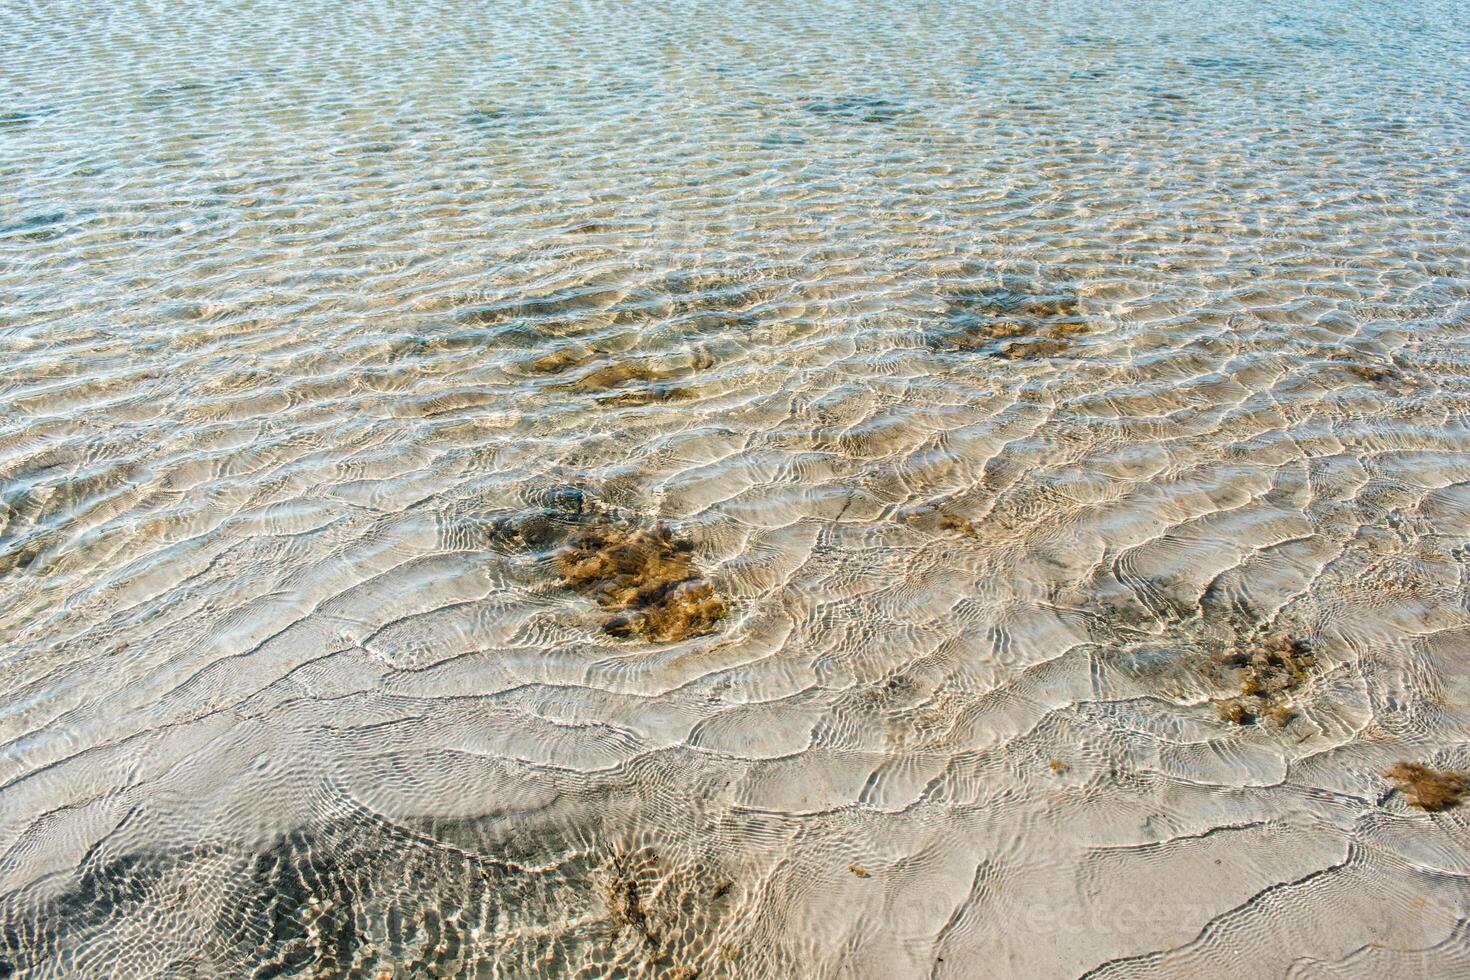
[0,818,739,980]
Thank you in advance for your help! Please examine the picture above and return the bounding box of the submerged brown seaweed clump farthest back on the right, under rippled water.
[931,288,1089,360]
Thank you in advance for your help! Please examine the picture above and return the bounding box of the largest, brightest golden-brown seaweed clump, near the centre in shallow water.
[556,523,729,642]
